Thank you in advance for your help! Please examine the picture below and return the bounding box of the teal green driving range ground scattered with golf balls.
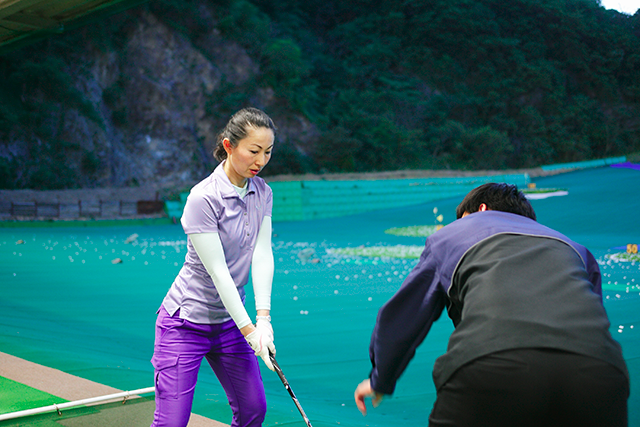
[0,167,640,427]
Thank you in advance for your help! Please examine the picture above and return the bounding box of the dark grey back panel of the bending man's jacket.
[434,233,625,392]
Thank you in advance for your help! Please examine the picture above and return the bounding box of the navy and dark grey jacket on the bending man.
[370,211,628,394]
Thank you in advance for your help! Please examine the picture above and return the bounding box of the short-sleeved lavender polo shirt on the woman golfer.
[162,162,273,323]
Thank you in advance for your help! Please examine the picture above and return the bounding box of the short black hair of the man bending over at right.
[456,182,536,221]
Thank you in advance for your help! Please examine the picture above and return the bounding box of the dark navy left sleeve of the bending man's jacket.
[369,239,446,394]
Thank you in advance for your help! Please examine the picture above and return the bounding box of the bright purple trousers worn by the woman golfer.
[151,307,267,427]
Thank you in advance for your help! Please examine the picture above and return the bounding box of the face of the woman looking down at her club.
[222,127,275,187]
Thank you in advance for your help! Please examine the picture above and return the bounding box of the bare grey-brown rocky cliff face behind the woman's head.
[0,8,316,188]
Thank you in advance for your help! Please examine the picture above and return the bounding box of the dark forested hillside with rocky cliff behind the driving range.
[0,0,640,189]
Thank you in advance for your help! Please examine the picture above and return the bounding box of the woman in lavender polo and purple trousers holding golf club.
[151,108,276,427]
